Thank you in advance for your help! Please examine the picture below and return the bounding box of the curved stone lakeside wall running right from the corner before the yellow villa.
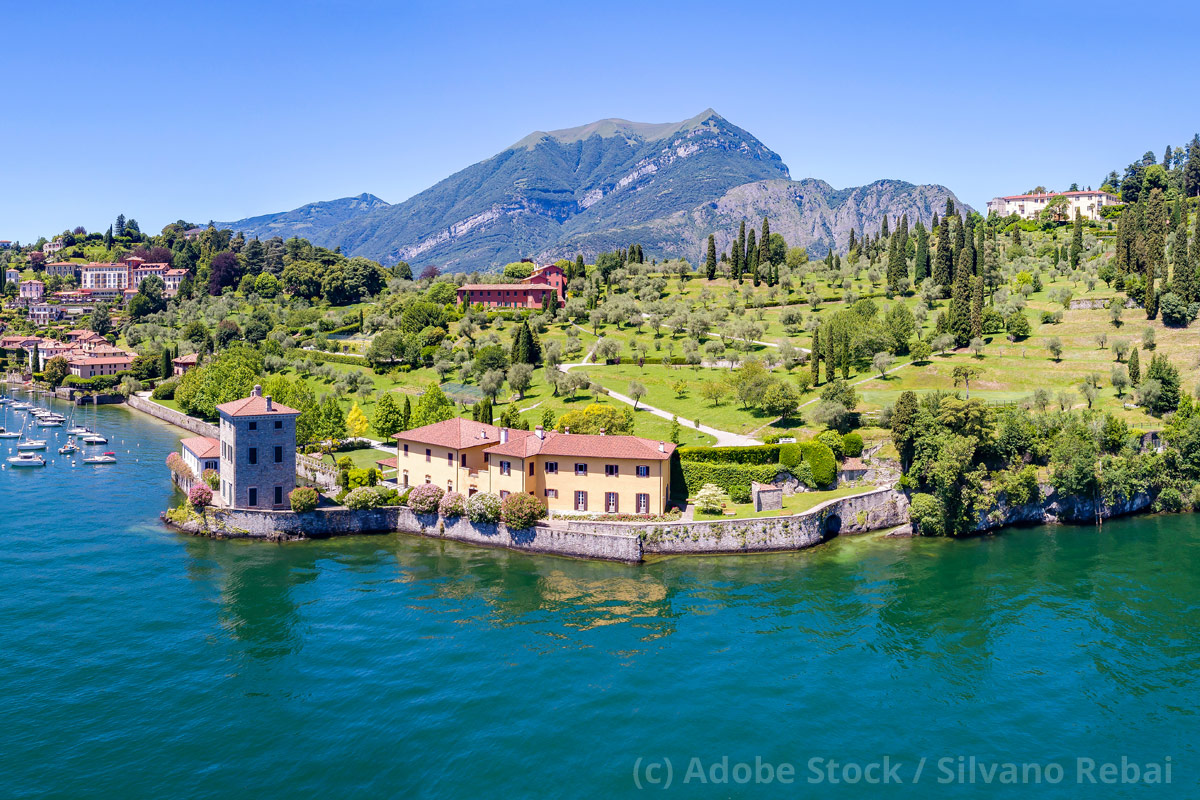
[568,488,908,555]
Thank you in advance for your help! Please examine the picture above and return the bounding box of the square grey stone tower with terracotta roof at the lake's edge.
[217,386,300,509]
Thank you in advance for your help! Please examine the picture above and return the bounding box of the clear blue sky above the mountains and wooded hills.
[0,0,1200,241]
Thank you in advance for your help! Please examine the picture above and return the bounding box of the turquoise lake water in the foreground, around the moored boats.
[0,393,1200,798]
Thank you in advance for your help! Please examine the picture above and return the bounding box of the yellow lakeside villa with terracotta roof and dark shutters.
[391,417,676,513]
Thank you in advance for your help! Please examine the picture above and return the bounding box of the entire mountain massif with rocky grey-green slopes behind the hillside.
[216,109,954,271]
